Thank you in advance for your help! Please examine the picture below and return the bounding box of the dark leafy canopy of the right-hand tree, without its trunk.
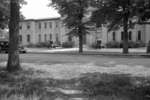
[91,0,145,31]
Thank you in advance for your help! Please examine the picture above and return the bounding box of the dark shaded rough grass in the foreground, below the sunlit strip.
[0,64,150,100]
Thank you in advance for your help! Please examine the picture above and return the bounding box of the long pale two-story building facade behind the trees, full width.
[15,18,150,46]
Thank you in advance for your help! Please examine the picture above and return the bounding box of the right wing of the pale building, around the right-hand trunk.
[103,24,150,44]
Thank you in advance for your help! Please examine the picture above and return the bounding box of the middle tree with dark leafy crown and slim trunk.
[51,0,90,53]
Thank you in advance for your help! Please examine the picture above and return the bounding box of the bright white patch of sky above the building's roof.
[21,0,60,19]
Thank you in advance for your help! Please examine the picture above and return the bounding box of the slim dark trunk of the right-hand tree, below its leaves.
[123,9,129,54]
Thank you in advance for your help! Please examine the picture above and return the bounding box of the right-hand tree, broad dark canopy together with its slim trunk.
[92,0,144,53]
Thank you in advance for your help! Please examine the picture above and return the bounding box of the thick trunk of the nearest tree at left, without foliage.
[7,0,21,72]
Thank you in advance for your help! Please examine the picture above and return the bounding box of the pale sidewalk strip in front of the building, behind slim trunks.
[27,48,150,57]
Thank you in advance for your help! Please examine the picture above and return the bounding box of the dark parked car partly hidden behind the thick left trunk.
[0,41,27,53]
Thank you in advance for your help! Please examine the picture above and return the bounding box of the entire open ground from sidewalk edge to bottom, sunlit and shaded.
[0,54,150,100]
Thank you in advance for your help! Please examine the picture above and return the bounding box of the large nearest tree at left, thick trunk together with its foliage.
[0,0,26,71]
